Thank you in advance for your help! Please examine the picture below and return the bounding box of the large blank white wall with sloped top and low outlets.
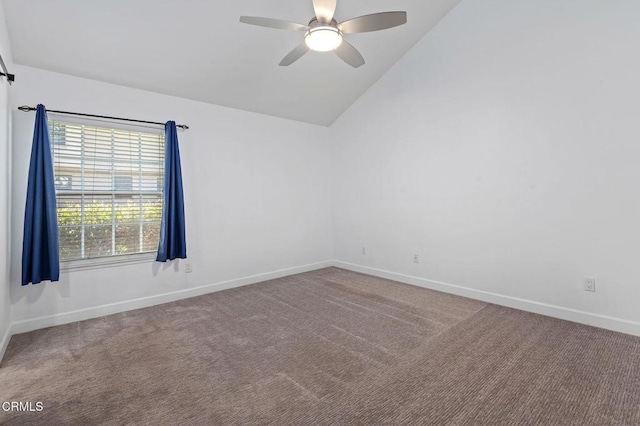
[331,0,640,330]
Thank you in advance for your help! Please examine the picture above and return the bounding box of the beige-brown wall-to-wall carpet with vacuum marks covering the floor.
[0,268,640,426]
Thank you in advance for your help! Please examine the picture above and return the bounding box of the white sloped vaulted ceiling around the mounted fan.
[3,0,459,125]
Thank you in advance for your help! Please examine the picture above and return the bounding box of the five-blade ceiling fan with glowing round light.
[240,0,407,68]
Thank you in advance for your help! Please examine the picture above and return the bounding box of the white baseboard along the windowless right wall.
[333,260,640,336]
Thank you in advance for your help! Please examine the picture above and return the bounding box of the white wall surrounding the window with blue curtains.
[11,66,332,324]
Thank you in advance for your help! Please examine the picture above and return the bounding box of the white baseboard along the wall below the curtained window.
[8,261,332,338]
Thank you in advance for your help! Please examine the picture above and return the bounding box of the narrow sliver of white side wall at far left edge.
[0,3,14,350]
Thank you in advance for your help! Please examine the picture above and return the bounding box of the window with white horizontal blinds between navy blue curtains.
[49,121,164,261]
